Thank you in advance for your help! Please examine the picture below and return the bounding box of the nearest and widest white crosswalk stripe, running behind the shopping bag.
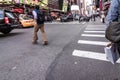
[72,50,120,63]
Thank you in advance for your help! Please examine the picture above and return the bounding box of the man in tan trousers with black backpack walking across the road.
[32,5,48,45]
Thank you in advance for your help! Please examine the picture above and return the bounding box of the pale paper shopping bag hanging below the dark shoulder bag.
[104,44,120,64]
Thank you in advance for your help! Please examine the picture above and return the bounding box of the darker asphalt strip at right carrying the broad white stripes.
[46,22,120,80]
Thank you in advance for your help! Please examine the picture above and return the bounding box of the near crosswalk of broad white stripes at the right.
[72,25,120,63]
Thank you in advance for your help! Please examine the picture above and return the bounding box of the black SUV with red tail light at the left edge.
[0,10,21,34]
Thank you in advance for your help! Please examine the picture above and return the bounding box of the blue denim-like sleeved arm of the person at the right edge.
[106,0,120,25]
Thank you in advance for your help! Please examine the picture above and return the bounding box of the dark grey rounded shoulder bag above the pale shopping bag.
[105,22,120,43]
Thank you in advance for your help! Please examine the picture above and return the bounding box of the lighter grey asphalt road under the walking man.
[0,23,86,80]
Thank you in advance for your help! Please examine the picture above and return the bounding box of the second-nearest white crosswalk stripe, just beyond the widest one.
[78,40,109,46]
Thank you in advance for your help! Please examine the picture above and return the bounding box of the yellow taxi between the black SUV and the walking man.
[19,14,34,27]
